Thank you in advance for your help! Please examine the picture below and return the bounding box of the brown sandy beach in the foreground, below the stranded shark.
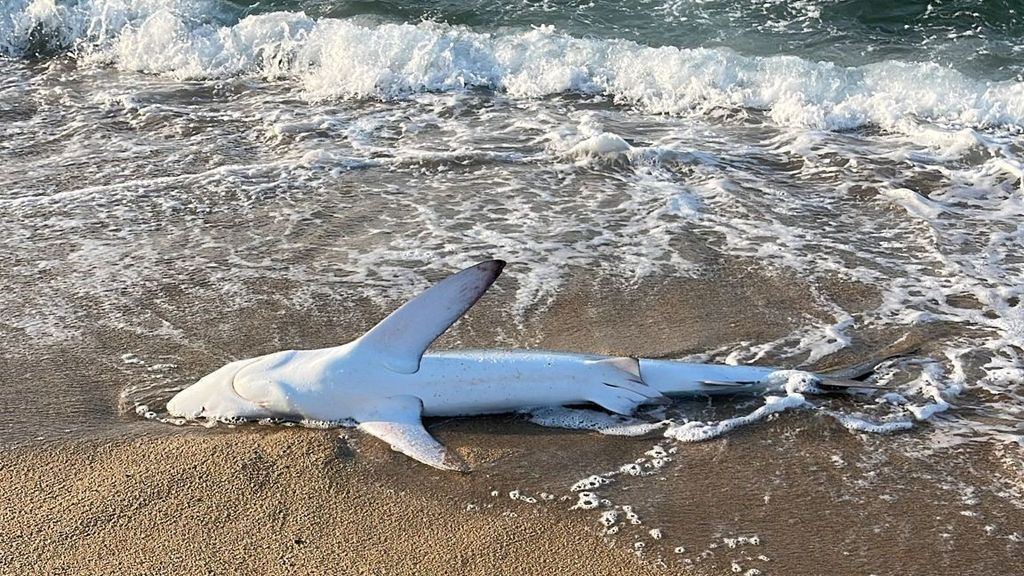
[0,415,1024,575]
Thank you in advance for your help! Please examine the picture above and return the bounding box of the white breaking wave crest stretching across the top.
[0,0,1024,131]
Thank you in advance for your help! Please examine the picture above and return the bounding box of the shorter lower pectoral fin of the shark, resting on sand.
[358,396,469,471]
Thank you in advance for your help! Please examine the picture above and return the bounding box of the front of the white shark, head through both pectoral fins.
[160,260,505,469]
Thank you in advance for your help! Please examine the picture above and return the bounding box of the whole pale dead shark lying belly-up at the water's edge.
[167,260,870,469]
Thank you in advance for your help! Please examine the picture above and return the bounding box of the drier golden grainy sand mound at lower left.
[0,430,651,575]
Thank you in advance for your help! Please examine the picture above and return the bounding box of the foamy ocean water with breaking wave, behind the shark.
[0,0,1024,565]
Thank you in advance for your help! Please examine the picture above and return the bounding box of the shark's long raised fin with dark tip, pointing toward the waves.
[351,260,505,374]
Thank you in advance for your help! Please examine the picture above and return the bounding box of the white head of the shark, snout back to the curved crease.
[167,357,273,420]
